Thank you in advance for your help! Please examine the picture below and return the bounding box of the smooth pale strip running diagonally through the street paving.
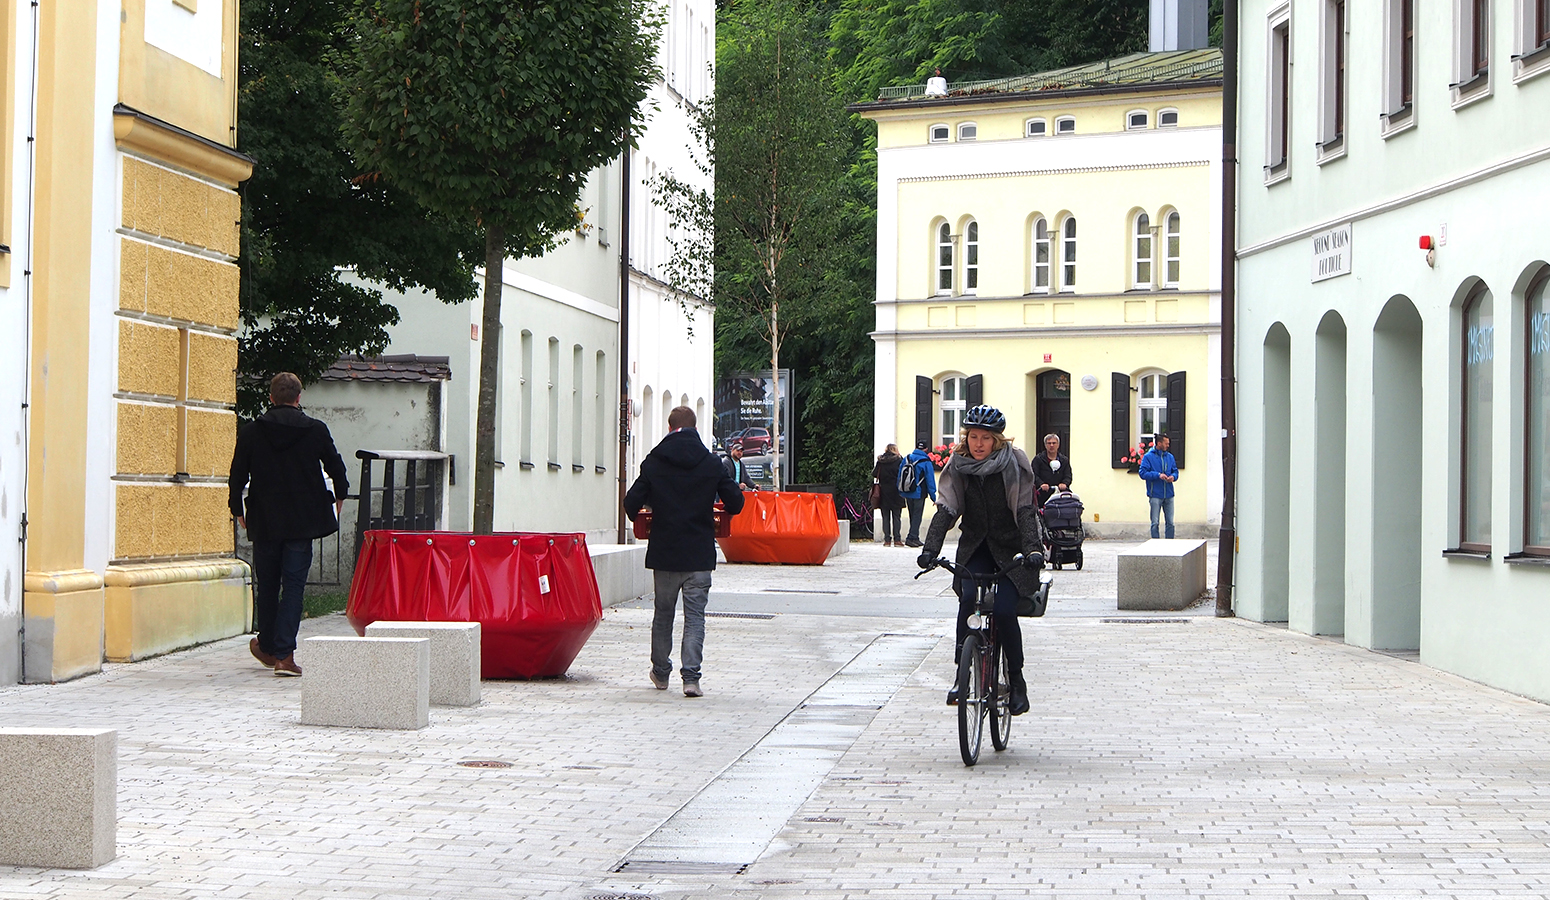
[612,634,941,872]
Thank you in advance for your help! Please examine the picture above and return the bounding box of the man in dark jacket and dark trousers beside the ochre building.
[229,372,350,675]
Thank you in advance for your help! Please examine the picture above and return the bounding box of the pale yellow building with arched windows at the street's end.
[853,50,1221,536]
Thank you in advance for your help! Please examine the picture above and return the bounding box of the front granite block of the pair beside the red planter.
[299,637,431,731]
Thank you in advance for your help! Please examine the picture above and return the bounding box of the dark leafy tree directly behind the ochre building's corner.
[237,0,479,417]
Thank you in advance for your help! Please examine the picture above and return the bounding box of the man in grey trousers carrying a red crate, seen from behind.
[625,406,742,697]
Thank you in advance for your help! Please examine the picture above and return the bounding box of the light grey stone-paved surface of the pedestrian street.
[0,544,1550,900]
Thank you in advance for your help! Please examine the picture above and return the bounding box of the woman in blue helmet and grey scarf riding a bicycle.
[919,404,1045,716]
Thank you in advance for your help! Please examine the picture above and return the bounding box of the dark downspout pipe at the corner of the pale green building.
[1217,0,1238,618]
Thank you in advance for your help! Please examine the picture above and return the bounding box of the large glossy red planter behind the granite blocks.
[344,531,603,678]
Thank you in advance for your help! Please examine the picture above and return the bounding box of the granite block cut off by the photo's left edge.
[0,728,118,869]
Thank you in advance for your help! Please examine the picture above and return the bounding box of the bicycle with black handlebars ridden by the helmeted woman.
[916,553,1049,765]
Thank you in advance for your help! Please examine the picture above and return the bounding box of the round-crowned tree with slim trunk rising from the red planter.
[349,0,659,533]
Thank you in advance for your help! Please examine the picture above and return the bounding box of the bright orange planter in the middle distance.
[716,491,840,565]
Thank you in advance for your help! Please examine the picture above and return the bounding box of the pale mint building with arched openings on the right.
[1237,0,1550,700]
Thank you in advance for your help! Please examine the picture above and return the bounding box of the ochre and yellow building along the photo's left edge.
[0,0,253,683]
